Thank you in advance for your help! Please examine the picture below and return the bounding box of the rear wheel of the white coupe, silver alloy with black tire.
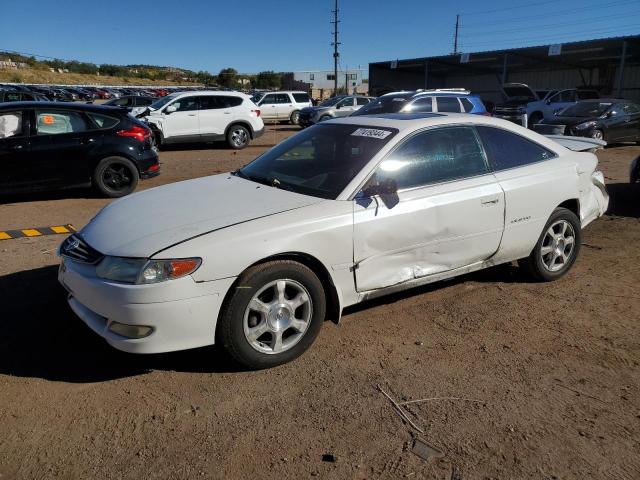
[518,207,582,282]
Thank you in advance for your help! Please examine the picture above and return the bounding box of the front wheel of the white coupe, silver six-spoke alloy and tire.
[216,260,326,369]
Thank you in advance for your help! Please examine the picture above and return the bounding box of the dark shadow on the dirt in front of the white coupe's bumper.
[0,266,244,383]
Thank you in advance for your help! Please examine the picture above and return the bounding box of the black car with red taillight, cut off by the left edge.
[0,102,160,197]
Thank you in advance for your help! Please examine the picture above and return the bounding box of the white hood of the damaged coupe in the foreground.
[80,174,322,258]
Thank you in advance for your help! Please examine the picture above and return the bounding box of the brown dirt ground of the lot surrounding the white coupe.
[0,126,640,480]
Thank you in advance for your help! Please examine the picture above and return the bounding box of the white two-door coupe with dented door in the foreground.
[59,114,608,368]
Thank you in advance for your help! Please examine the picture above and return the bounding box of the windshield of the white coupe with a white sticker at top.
[235,124,398,200]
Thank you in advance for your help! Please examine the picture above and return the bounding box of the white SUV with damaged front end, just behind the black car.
[144,91,264,150]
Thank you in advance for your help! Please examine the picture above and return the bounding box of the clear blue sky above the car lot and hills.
[0,0,640,73]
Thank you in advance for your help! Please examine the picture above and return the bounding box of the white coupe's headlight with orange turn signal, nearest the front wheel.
[96,257,202,285]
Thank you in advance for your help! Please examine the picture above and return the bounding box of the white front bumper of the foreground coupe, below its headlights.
[58,258,235,353]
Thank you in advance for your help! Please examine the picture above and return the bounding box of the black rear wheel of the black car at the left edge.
[92,157,140,198]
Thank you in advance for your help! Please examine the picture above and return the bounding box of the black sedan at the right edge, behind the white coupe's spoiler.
[533,99,640,143]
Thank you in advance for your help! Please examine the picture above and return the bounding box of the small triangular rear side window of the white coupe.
[476,126,556,170]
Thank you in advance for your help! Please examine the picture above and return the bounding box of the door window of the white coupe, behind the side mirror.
[375,127,488,189]
